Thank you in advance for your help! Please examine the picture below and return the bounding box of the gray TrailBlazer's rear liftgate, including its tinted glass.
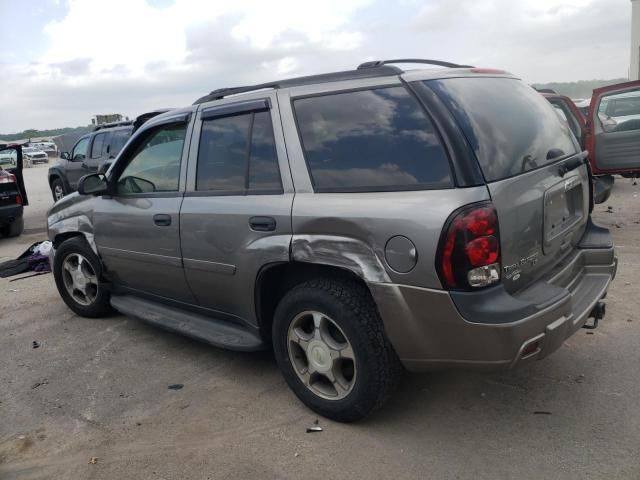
[425,76,589,292]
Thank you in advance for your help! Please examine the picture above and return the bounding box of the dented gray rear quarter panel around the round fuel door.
[291,187,489,288]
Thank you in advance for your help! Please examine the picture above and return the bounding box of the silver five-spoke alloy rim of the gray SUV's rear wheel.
[287,311,357,400]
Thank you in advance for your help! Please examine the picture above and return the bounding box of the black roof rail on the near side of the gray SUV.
[193,65,402,105]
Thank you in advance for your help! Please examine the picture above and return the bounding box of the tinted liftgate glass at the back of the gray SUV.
[424,77,577,181]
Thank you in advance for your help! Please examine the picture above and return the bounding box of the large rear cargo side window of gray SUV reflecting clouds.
[293,87,452,192]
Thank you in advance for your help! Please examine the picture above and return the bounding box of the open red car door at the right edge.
[586,81,640,174]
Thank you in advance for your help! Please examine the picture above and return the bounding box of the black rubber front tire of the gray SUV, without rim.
[53,237,112,318]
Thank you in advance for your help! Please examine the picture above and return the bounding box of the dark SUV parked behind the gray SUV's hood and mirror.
[49,109,167,200]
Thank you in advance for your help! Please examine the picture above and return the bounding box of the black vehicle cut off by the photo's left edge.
[0,144,29,237]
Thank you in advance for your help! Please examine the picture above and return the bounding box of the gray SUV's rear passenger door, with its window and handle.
[180,92,293,323]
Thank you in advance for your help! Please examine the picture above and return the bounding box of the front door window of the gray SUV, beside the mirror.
[117,125,186,194]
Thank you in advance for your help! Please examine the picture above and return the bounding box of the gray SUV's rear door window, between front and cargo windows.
[196,111,282,194]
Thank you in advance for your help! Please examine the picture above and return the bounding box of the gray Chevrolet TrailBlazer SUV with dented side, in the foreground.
[48,60,617,421]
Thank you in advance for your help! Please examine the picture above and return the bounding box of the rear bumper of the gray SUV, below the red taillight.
[370,232,617,371]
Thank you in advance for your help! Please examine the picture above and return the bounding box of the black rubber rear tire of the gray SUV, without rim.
[272,278,403,422]
